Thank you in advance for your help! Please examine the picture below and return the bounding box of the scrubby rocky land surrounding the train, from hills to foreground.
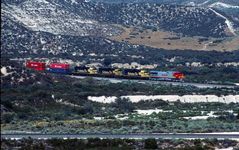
[0,0,239,149]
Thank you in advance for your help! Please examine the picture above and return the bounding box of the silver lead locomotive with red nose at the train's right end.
[149,71,184,81]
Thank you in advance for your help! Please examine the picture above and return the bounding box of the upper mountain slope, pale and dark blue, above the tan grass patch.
[2,0,233,37]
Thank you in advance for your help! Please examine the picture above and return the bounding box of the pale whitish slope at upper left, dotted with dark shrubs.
[2,0,120,36]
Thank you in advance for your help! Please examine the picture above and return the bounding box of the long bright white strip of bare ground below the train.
[88,95,239,103]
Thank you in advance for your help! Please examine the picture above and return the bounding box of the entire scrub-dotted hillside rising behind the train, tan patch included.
[1,0,239,59]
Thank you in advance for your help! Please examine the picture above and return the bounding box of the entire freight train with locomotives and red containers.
[26,61,185,81]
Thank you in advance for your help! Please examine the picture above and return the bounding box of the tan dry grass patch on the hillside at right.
[110,27,239,51]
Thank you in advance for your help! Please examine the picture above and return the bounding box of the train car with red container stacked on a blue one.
[48,63,71,74]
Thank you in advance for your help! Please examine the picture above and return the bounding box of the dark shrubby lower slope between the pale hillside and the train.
[1,1,238,63]
